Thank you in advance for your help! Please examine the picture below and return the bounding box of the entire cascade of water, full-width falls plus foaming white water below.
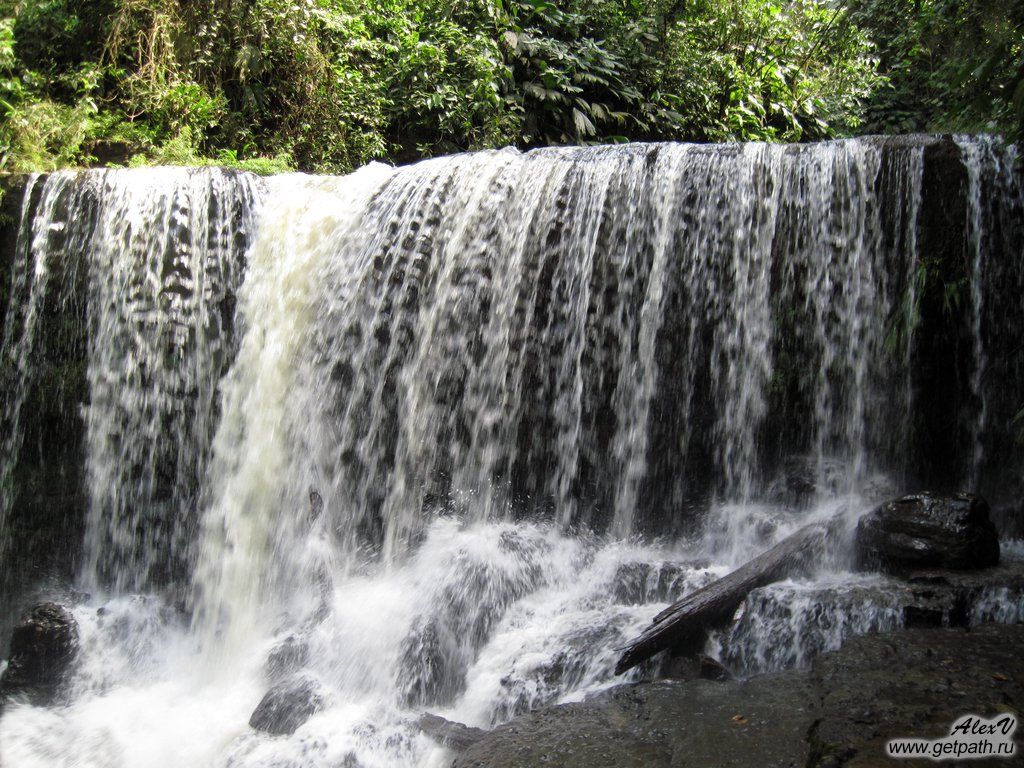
[0,138,1024,768]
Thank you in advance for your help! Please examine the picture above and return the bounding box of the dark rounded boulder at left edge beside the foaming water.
[0,603,78,706]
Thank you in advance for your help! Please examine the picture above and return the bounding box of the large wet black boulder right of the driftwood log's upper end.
[856,494,999,572]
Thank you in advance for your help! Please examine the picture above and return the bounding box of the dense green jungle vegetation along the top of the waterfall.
[0,0,1024,172]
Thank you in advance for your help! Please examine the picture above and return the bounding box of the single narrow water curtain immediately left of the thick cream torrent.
[84,169,258,591]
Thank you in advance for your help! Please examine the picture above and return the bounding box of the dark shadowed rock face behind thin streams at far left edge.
[0,175,91,656]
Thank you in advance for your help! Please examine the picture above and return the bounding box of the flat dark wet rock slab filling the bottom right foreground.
[453,625,1024,768]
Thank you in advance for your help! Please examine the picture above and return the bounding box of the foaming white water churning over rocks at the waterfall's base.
[0,520,723,767]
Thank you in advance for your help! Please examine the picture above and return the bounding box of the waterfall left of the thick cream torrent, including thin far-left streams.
[0,168,258,591]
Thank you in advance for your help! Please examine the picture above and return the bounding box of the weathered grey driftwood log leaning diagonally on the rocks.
[615,523,828,675]
